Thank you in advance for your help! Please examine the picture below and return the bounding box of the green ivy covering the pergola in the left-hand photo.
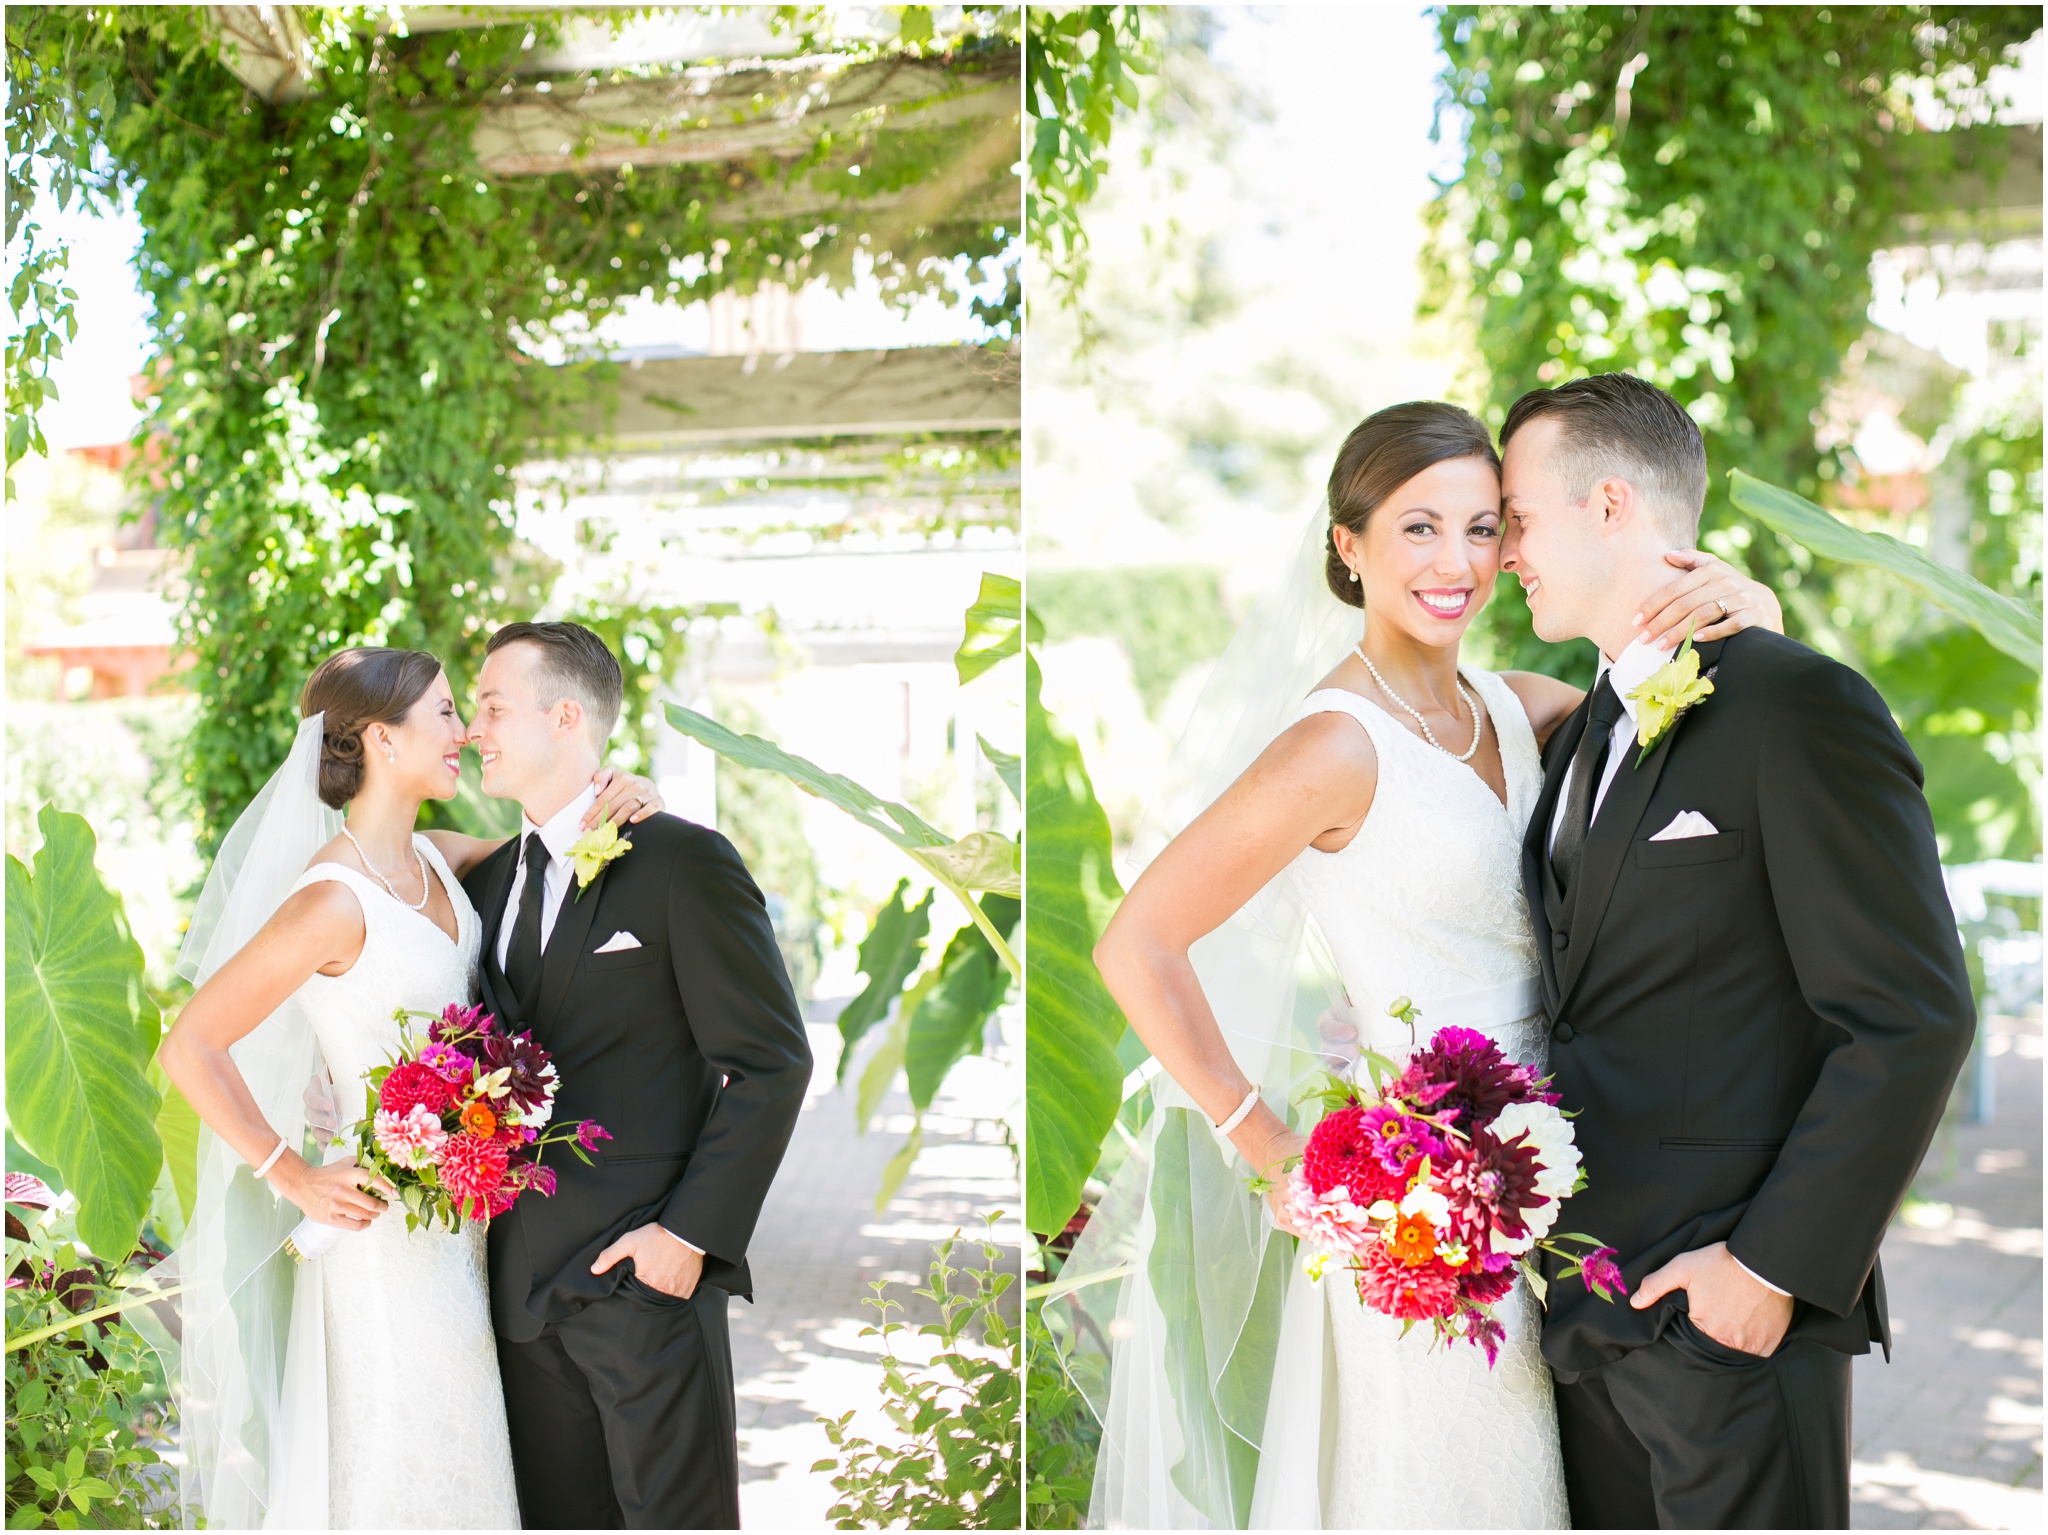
[6,6,1018,835]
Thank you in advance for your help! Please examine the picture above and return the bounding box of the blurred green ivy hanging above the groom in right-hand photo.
[1432,6,2042,679]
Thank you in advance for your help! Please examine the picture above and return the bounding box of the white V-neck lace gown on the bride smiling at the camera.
[1255,667,1571,1529]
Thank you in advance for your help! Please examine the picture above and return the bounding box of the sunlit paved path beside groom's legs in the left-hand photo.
[731,1025,1022,1529]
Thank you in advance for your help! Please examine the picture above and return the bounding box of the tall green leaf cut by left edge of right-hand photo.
[1024,653,1124,1232]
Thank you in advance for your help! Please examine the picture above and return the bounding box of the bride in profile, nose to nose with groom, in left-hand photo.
[160,647,659,1529]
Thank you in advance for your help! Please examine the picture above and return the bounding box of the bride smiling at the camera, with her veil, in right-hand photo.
[1059,403,1780,1529]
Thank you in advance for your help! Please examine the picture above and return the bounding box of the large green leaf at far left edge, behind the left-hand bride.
[6,804,164,1259]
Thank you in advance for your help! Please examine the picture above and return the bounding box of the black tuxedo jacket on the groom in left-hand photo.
[463,815,811,1343]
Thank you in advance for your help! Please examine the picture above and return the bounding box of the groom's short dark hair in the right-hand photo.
[1501,372,1706,549]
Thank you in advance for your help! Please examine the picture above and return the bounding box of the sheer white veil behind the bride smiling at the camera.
[1047,508,1364,1529]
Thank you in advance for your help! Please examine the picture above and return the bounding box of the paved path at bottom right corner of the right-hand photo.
[1853,1013,2042,1529]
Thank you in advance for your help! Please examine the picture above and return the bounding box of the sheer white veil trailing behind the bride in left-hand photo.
[141,714,342,1529]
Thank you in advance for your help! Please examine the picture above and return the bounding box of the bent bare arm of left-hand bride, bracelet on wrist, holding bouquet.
[158,882,391,1230]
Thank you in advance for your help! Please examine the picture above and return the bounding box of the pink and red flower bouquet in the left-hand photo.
[289,1003,610,1261]
